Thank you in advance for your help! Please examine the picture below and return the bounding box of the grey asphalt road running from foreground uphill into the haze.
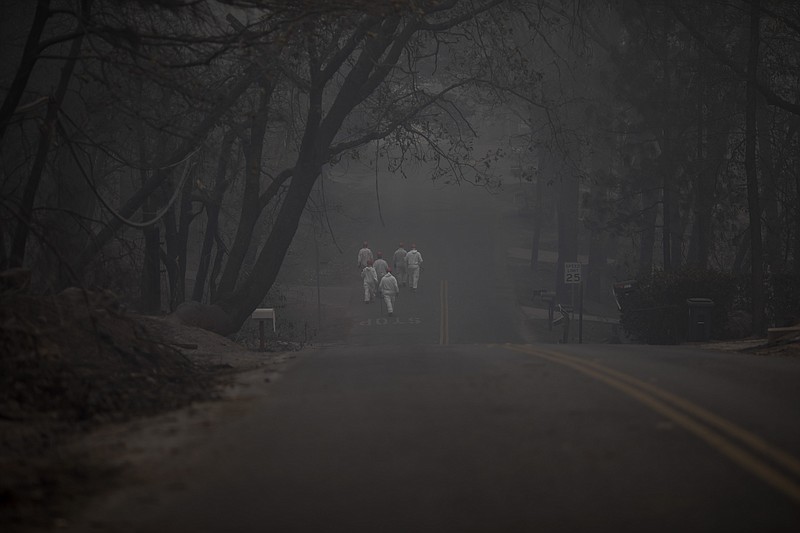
[66,172,800,533]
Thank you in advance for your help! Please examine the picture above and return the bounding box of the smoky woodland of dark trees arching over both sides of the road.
[0,0,800,335]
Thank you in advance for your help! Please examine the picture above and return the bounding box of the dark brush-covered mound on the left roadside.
[0,289,219,432]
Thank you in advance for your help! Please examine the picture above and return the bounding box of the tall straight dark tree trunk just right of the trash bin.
[745,0,766,335]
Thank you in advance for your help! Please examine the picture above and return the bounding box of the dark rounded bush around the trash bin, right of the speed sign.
[620,267,736,344]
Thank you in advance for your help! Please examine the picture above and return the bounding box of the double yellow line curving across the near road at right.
[505,345,800,503]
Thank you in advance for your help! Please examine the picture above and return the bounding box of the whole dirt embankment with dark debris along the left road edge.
[0,280,287,531]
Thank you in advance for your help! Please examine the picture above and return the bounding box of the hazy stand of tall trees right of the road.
[494,0,800,333]
